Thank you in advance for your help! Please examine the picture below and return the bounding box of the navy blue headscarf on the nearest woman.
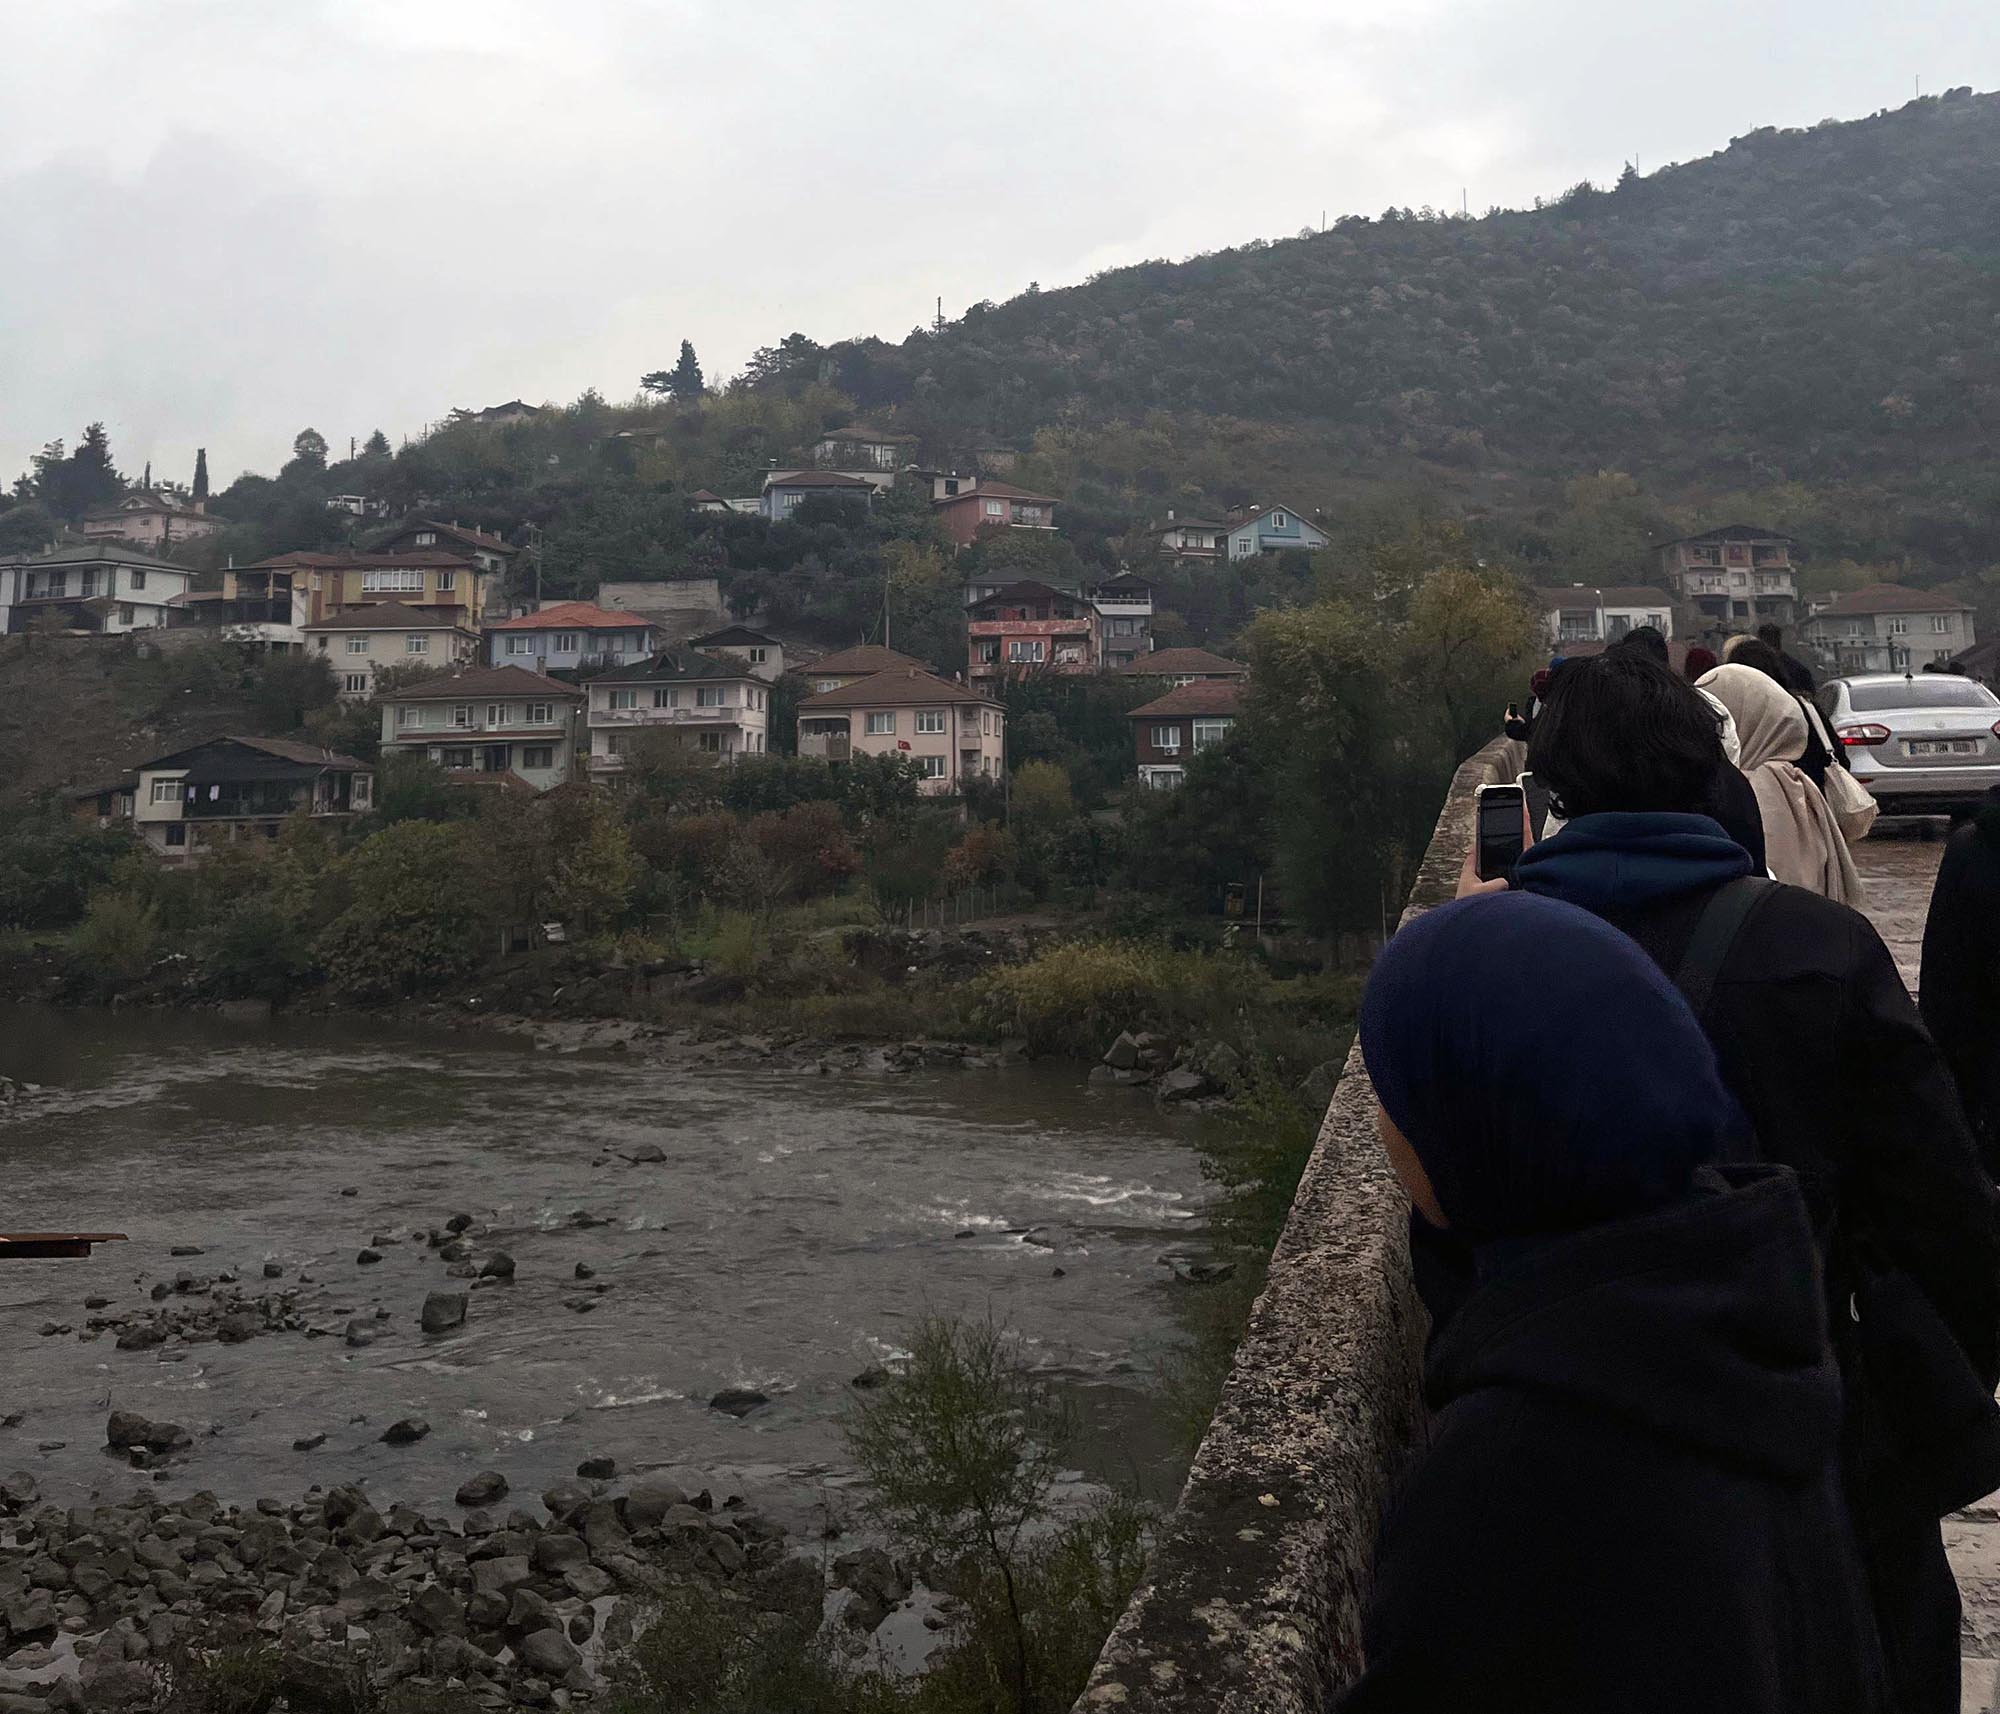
[1360,892,1750,1242]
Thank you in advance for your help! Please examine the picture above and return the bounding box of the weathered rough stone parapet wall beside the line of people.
[1076,740,1522,1714]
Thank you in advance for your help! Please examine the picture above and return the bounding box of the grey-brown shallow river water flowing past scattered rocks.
[0,1006,1204,1528]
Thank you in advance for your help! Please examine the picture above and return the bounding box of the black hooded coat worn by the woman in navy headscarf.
[1342,1166,1888,1714]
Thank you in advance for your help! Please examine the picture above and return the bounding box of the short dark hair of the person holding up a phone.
[1528,648,1728,820]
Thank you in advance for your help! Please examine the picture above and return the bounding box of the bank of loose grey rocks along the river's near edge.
[0,1448,844,1714]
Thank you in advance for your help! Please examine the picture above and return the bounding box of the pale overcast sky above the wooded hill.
[0,0,2000,486]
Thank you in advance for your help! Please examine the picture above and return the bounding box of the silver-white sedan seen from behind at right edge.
[1818,672,2000,816]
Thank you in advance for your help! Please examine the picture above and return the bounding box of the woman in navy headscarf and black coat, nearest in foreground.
[1340,894,1890,1714]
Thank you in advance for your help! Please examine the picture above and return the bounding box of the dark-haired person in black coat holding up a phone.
[1514,656,2000,1714]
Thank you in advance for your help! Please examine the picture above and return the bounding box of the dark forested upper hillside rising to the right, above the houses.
[804,90,2000,482]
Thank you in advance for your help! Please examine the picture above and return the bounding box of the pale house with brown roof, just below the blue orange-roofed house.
[382,666,584,792]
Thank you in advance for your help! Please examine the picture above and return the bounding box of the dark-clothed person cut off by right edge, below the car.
[1916,786,2000,1176]
